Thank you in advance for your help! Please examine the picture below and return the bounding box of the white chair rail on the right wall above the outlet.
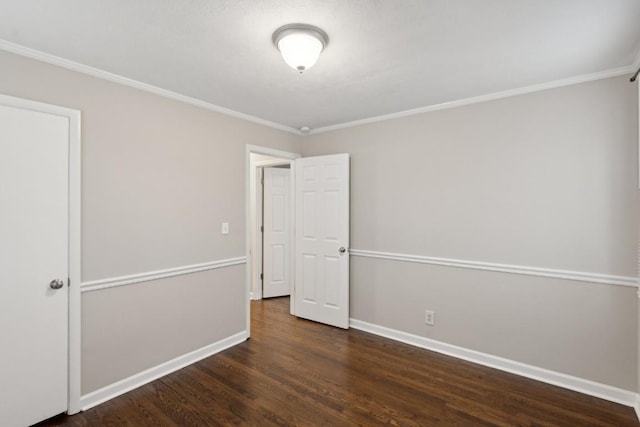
[349,249,638,288]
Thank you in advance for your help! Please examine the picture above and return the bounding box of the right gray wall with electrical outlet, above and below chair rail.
[302,77,638,390]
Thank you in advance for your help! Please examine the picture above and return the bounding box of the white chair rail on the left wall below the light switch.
[81,257,247,292]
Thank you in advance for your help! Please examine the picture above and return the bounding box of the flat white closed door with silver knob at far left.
[0,104,69,426]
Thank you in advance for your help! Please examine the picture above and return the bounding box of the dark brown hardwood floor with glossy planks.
[39,298,639,427]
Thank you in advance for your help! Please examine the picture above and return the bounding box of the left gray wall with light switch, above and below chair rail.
[0,51,299,394]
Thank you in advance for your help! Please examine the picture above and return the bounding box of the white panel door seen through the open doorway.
[262,168,291,298]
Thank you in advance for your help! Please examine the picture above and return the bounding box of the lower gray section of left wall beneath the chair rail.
[82,265,246,390]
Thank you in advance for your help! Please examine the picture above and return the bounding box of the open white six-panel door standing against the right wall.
[294,154,349,329]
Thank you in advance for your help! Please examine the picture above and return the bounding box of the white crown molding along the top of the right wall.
[309,65,633,134]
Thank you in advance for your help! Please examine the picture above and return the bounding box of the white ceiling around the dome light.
[0,0,640,133]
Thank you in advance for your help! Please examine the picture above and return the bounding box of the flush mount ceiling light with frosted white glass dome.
[273,24,329,74]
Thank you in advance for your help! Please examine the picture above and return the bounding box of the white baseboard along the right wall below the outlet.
[349,319,638,406]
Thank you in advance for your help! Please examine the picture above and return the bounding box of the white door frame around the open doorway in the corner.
[245,144,302,337]
